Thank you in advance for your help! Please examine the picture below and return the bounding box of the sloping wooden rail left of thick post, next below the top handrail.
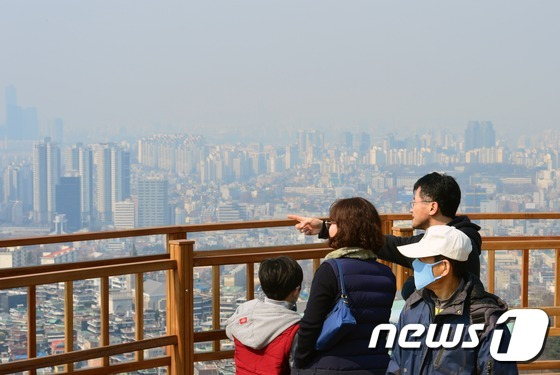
[0,260,176,289]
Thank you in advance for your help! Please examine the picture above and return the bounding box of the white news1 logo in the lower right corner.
[369,309,549,362]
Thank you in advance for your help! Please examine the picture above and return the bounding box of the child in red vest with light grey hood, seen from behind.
[226,257,303,375]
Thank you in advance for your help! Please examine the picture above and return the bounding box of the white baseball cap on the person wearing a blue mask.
[397,225,472,262]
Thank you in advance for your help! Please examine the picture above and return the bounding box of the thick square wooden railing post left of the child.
[167,240,194,375]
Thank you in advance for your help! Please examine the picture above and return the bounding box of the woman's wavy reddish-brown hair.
[329,197,384,254]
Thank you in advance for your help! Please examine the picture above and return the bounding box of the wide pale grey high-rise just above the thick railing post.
[138,177,170,227]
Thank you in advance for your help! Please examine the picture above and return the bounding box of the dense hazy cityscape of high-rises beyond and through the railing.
[0,86,560,373]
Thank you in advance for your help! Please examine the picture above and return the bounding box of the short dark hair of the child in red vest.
[259,257,303,301]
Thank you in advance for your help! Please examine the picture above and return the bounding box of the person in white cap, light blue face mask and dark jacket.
[387,225,518,375]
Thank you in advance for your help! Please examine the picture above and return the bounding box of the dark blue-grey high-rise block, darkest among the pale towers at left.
[56,177,81,232]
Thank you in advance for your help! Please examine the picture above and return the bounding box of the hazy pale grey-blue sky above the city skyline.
[0,0,560,142]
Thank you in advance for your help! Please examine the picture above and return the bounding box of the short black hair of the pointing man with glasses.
[414,172,461,218]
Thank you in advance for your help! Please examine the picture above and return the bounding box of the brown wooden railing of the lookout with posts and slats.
[0,213,560,374]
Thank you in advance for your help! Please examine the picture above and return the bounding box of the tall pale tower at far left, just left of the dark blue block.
[33,138,60,224]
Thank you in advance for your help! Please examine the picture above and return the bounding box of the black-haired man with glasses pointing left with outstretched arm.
[288,172,482,299]
